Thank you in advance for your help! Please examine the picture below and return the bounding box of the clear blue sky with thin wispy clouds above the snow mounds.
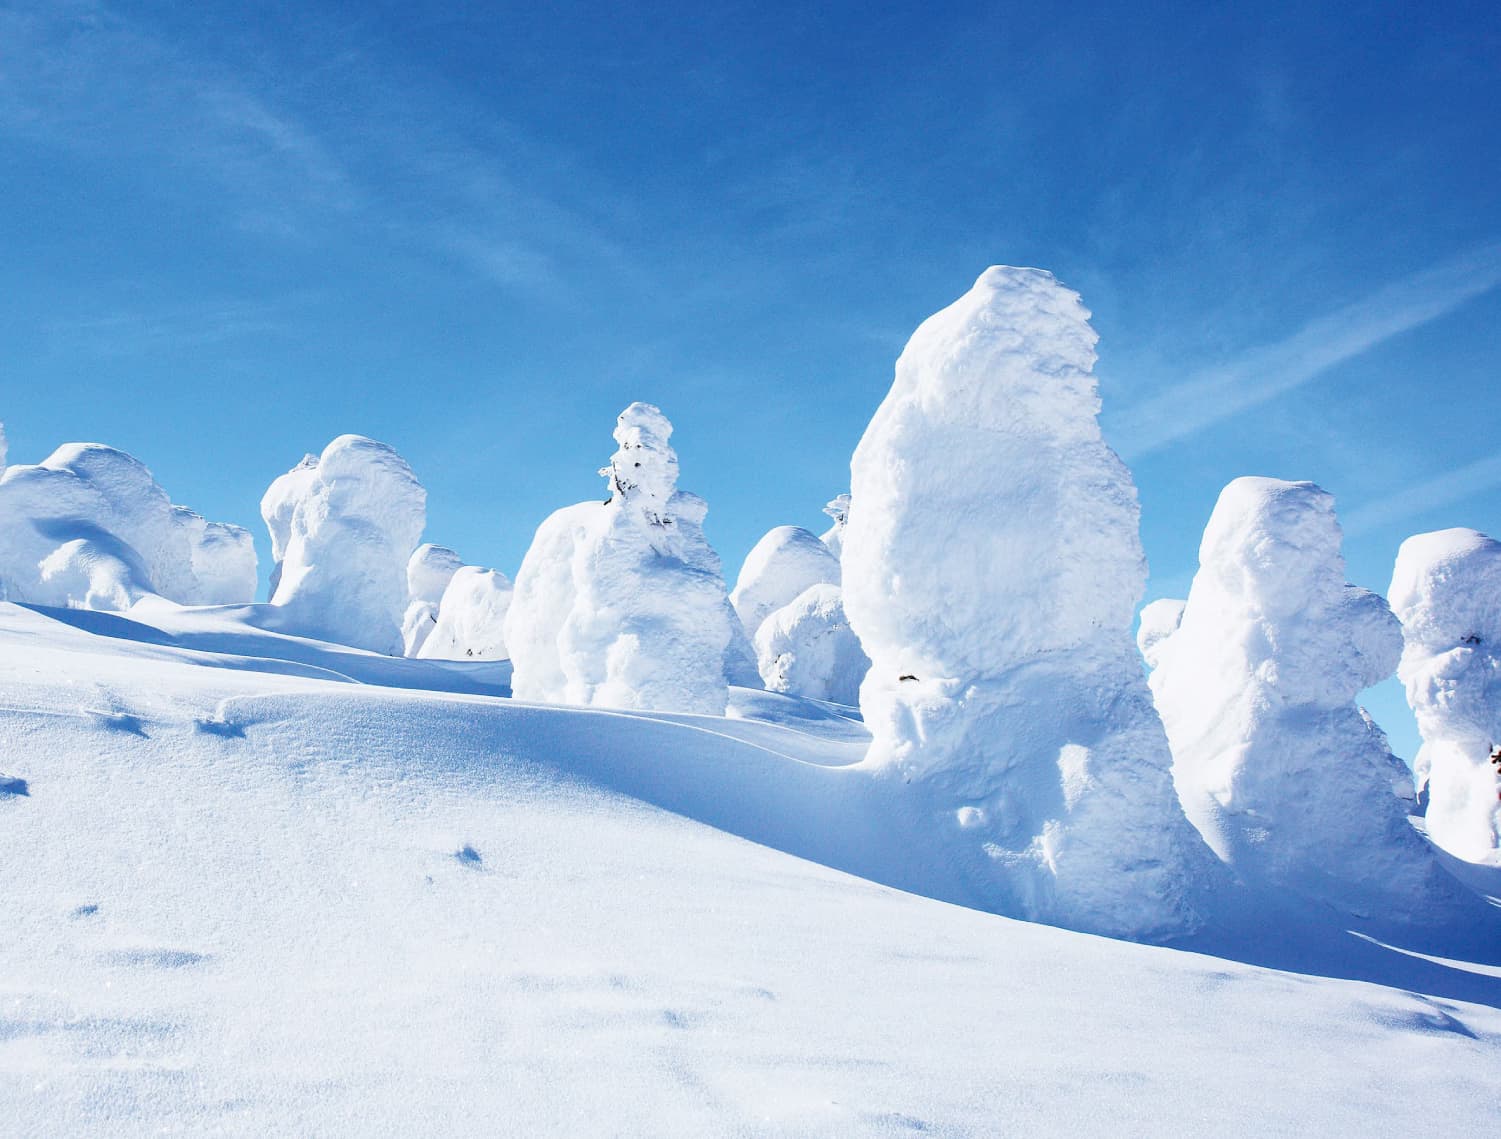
[0,0,1501,762]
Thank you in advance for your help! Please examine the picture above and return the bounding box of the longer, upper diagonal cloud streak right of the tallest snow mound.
[1111,242,1501,459]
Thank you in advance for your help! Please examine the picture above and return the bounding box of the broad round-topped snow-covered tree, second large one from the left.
[261,435,426,656]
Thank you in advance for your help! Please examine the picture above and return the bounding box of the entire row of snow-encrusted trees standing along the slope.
[0,267,1501,938]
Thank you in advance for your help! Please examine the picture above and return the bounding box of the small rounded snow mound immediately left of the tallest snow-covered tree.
[755,585,871,704]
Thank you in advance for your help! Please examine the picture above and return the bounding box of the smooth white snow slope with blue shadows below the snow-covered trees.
[0,600,1501,1136]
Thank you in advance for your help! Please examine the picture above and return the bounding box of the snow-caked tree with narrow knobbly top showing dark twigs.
[506,404,732,714]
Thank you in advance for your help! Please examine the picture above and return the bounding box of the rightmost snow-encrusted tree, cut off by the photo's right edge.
[1390,530,1501,864]
